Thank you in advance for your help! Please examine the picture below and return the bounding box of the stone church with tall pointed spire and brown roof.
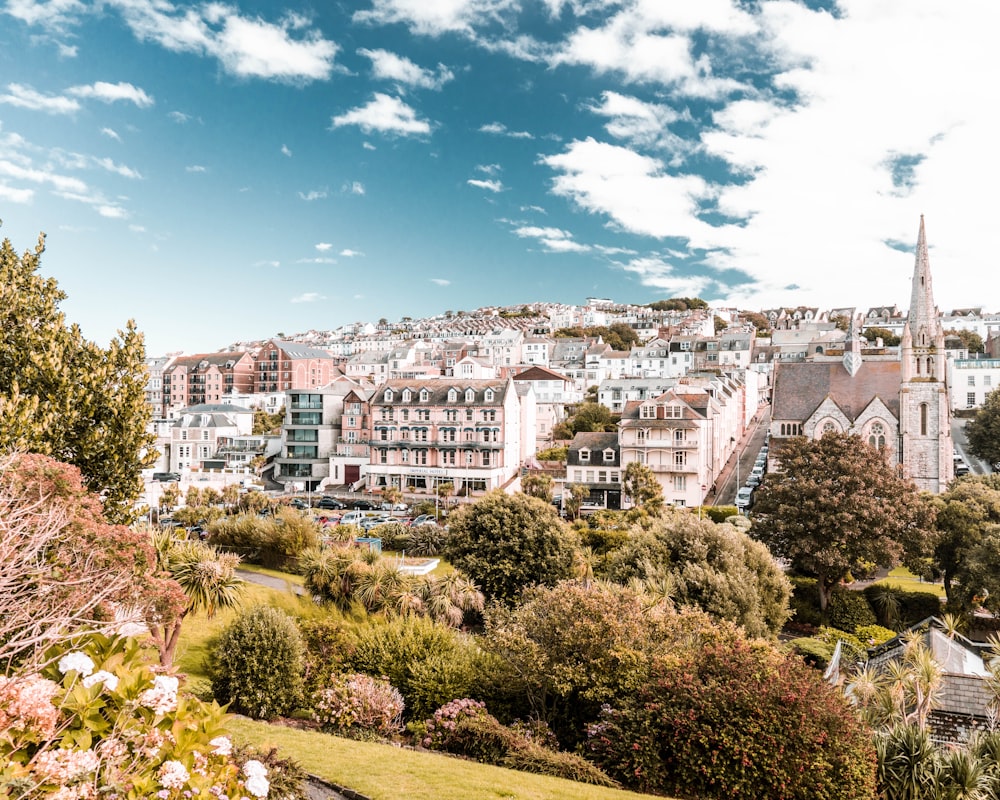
[770,216,954,494]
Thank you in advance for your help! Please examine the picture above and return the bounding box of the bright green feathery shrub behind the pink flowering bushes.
[345,617,482,719]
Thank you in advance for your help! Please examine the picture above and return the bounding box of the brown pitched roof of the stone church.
[772,361,900,422]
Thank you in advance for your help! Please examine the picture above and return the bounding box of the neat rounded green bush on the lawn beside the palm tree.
[210,606,305,719]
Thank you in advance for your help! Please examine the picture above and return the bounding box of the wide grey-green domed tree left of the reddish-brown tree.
[605,509,791,636]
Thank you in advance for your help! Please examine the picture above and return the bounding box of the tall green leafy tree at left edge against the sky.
[0,230,156,523]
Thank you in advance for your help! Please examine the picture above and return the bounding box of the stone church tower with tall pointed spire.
[899,216,954,494]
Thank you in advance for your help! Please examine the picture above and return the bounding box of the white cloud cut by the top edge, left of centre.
[354,0,517,36]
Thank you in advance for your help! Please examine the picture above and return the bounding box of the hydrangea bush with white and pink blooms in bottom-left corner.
[0,634,269,800]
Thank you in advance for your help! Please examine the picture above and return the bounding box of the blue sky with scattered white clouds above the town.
[0,0,1000,355]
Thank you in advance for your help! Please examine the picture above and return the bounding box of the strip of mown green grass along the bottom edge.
[227,717,664,800]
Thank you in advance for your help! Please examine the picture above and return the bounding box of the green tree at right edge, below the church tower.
[933,475,1000,603]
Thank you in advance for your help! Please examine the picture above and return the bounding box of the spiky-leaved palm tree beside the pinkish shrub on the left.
[150,532,246,667]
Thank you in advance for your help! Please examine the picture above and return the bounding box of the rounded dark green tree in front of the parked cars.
[443,490,576,605]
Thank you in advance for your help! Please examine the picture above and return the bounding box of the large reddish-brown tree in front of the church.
[752,433,934,611]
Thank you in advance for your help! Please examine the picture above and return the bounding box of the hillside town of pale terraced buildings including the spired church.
[146,219,1000,509]
